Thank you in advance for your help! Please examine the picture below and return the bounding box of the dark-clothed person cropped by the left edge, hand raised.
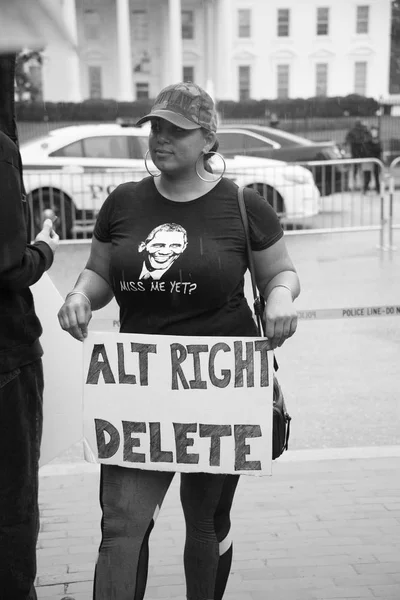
[0,54,58,600]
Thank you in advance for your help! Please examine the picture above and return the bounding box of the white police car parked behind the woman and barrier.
[21,124,320,237]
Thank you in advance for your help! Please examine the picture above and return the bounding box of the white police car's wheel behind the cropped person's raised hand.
[29,188,74,239]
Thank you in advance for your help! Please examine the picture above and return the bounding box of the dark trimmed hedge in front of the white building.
[16,94,379,122]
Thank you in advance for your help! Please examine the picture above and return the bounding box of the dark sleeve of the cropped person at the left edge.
[0,154,53,291]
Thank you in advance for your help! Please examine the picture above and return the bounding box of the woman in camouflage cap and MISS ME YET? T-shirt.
[59,83,300,600]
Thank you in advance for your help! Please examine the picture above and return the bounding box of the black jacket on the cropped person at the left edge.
[0,131,53,373]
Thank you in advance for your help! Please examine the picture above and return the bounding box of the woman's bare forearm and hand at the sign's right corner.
[253,239,300,350]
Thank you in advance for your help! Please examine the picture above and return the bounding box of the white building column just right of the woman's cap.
[214,0,231,100]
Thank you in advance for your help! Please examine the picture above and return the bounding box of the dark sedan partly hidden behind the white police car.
[218,124,348,196]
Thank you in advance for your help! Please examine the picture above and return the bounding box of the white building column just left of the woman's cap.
[116,0,134,102]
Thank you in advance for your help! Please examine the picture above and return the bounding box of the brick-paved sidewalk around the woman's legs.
[37,447,400,600]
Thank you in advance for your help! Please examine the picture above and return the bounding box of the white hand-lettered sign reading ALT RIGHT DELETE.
[83,332,273,475]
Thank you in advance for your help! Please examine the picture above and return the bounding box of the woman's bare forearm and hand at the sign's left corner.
[58,237,114,342]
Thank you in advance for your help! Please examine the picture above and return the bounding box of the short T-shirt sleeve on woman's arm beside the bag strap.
[245,189,283,251]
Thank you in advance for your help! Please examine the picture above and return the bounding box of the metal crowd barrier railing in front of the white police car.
[24,157,400,249]
